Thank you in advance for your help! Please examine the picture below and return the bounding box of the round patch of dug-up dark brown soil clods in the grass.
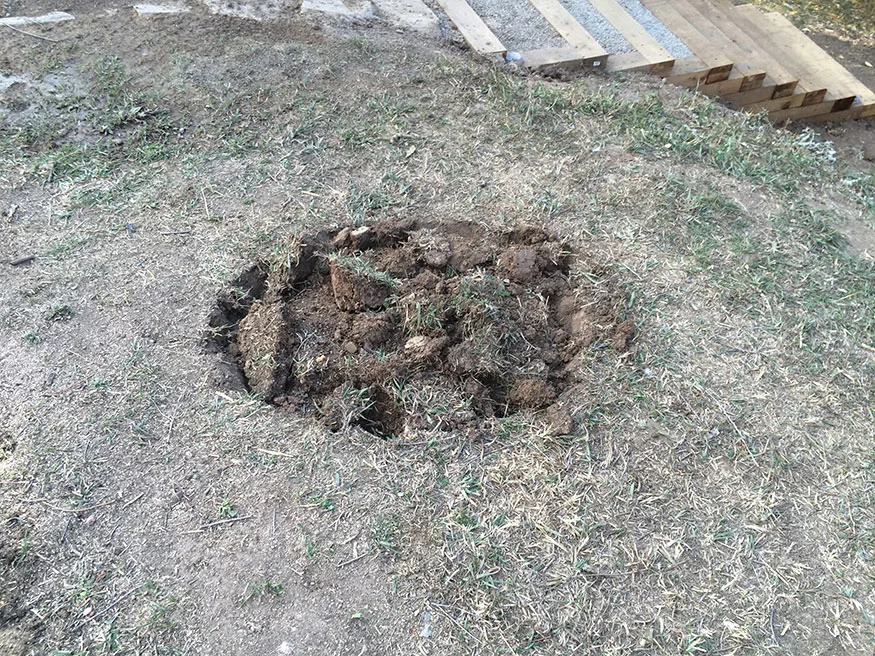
[210,220,635,436]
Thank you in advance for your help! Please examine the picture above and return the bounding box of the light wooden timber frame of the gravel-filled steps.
[437,0,875,122]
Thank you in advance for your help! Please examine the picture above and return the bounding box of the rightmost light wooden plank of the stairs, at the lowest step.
[735,5,875,105]
